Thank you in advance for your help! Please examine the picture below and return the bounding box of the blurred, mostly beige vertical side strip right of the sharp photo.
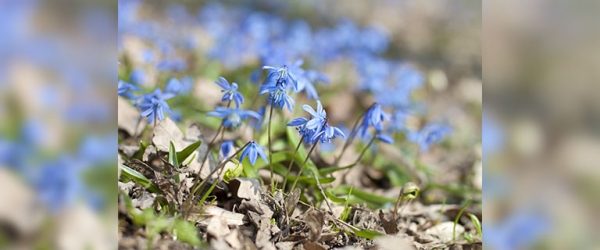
[482,0,600,249]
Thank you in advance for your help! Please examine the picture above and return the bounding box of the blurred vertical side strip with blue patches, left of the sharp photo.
[0,0,117,249]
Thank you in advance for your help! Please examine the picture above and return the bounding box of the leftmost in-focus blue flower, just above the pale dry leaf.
[138,89,173,123]
